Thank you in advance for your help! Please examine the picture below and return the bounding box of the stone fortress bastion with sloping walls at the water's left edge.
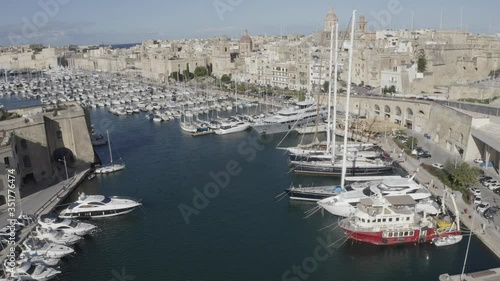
[0,104,97,201]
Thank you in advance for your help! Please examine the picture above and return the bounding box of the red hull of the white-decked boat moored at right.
[343,228,460,245]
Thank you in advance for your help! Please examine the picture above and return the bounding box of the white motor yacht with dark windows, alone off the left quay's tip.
[59,193,142,219]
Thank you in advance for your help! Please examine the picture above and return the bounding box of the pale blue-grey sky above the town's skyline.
[0,0,500,46]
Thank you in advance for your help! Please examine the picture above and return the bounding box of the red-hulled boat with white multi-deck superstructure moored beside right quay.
[339,190,461,245]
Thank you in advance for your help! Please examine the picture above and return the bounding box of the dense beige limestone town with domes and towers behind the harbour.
[0,9,500,103]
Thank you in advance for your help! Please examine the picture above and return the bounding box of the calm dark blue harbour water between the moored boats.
[0,101,500,281]
